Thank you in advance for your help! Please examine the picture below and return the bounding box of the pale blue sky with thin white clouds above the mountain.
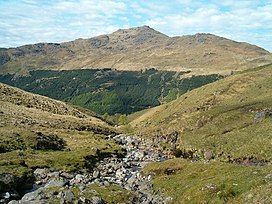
[0,0,272,51]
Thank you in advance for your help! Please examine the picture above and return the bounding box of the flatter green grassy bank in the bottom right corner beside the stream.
[144,159,272,204]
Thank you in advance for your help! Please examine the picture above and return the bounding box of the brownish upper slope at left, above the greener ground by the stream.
[0,83,110,132]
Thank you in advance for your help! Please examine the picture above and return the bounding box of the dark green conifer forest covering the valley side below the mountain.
[0,69,222,115]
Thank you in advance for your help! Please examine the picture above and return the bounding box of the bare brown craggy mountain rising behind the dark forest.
[0,26,272,75]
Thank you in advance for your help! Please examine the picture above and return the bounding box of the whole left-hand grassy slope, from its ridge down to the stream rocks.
[0,84,120,176]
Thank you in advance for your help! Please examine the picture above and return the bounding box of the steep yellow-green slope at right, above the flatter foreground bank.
[131,65,272,164]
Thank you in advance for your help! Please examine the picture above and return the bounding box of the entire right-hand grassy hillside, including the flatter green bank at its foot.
[130,65,272,204]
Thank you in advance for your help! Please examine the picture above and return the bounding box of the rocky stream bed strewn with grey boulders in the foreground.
[0,134,171,204]
